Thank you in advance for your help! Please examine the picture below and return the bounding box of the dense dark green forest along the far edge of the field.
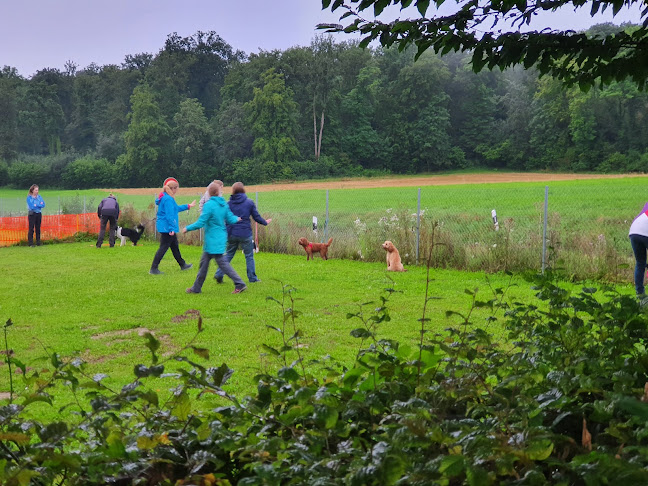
[0,24,648,189]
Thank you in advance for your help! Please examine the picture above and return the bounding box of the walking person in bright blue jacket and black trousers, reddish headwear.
[149,177,196,275]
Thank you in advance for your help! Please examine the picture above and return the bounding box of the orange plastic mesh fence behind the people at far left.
[0,213,99,246]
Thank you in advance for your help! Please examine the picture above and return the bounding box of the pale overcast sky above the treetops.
[0,0,640,77]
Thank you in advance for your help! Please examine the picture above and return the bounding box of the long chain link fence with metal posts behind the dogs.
[0,180,645,281]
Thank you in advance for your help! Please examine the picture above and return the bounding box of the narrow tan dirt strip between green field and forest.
[106,172,648,195]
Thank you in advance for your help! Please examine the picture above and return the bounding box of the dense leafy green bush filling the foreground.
[0,279,648,485]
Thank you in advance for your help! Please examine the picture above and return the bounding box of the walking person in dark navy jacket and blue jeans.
[214,182,272,283]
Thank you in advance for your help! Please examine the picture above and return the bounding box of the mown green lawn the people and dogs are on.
[0,242,616,410]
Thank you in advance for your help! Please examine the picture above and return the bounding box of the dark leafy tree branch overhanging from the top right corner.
[318,0,648,89]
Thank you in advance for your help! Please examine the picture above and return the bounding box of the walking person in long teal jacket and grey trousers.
[182,182,247,294]
